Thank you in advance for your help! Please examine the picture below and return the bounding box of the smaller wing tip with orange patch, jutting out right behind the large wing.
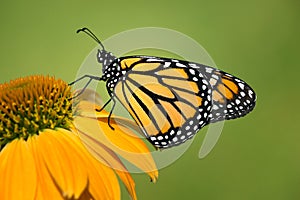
[189,63,256,123]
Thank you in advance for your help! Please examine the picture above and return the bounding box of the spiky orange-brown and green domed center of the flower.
[0,76,73,150]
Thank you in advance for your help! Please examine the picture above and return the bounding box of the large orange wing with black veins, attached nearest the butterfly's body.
[114,57,212,148]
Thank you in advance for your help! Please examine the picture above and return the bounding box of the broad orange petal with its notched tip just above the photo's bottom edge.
[36,130,87,198]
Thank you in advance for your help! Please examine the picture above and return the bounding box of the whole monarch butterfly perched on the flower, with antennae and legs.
[70,28,256,148]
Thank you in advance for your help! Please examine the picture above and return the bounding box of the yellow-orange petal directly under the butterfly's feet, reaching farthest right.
[74,116,158,181]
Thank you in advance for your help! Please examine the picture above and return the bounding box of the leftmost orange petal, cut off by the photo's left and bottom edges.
[0,139,37,200]
